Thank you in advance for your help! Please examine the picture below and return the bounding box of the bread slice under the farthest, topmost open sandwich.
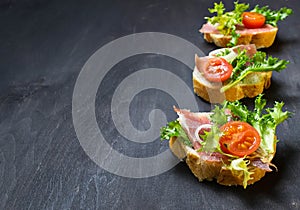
[204,27,278,49]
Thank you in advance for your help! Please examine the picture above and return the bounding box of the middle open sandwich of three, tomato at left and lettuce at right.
[193,44,289,103]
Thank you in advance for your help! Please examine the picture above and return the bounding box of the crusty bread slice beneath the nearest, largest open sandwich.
[169,137,266,186]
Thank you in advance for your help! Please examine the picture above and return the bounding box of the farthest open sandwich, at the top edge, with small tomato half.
[199,1,292,48]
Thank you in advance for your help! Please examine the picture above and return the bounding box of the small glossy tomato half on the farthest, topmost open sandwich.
[242,12,266,28]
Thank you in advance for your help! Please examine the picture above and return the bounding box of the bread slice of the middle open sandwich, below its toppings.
[193,64,272,103]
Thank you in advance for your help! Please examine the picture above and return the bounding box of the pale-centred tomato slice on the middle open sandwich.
[204,57,233,82]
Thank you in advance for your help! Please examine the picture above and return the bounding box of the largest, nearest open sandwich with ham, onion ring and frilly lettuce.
[161,95,291,188]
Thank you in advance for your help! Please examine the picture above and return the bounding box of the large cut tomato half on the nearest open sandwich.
[219,121,261,157]
